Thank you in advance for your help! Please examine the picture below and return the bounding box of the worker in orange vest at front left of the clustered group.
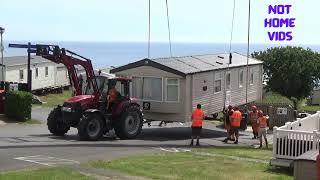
[223,106,242,144]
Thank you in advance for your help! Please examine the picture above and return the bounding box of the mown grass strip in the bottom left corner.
[0,167,94,180]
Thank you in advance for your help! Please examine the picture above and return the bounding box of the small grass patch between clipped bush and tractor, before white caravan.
[40,90,72,107]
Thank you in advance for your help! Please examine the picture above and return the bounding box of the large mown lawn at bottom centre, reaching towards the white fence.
[91,148,293,180]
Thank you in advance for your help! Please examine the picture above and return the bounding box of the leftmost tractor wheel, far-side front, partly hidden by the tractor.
[47,106,70,136]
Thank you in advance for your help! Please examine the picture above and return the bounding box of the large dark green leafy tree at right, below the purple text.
[252,46,320,107]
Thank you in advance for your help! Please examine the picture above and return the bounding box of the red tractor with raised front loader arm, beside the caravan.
[36,45,143,140]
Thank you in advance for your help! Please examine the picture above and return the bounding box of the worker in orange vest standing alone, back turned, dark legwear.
[190,104,205,146]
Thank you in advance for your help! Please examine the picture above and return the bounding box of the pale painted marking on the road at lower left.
[14,155,80,166]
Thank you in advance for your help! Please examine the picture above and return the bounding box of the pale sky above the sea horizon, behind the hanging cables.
[0,0,320,44]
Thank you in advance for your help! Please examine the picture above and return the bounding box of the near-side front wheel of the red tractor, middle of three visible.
[78,113,104,141]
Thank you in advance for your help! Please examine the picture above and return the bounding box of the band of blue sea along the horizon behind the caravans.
[4,41,320,68]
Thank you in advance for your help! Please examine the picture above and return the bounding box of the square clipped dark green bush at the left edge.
[5,91,32,121]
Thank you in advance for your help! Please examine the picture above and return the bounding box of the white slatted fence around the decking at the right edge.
[273,111,320,159]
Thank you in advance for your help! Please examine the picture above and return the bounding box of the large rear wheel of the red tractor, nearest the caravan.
[114,106,143,139]
